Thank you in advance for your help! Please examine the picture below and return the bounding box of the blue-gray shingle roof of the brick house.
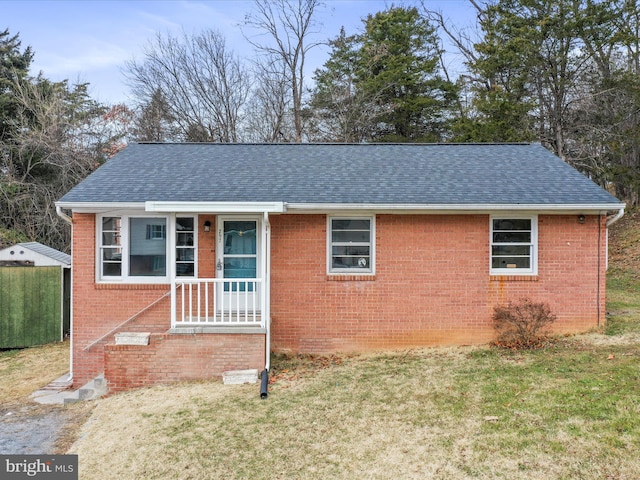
[60,143,620,206]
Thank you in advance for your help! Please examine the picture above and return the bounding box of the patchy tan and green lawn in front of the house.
[5,212,640,480]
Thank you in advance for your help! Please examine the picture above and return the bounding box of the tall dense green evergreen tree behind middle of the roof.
[356,7,457,142]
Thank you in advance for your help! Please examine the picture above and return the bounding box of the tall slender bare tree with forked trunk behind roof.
[245,0,323,142]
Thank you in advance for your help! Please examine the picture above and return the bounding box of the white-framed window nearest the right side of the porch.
[327,216,375,274]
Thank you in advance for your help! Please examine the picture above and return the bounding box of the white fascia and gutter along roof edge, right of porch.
[285,203,624,214]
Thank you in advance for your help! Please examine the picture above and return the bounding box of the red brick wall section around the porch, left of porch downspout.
[73,213,265,388]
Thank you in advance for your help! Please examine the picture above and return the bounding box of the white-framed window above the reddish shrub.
[490,215,538,275]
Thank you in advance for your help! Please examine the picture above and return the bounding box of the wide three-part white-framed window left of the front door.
[96,213,197,283]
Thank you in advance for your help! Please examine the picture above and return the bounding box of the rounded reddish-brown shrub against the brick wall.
[493,298,556,349]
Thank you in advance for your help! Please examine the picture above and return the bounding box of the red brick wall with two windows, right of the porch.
[271,215,606,353]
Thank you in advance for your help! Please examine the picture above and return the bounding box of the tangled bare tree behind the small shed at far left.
[0,78,109,250]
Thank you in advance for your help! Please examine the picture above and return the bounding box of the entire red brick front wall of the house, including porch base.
[73,214,606,388]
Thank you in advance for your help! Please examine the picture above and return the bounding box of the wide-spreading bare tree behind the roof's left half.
[125,30,251,142]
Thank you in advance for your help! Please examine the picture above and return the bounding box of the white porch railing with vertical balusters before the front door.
[171,278,266,328]
